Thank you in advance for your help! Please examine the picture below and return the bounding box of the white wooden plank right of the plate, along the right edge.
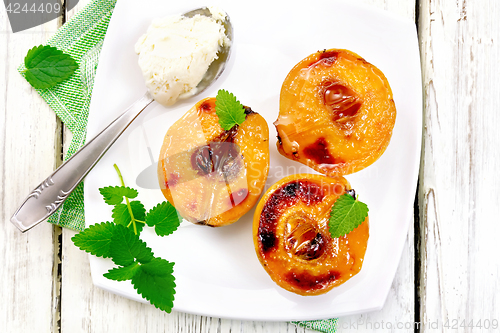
[419,0,500,332]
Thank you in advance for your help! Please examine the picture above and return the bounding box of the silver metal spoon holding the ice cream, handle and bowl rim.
[10,7,233,232]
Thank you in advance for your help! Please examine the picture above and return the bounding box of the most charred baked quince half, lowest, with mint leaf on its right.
[253,174,368,296]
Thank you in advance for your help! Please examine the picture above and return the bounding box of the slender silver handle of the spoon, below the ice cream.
[10,93,153,232]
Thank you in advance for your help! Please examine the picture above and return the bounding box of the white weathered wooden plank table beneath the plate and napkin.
[0,0,500,333]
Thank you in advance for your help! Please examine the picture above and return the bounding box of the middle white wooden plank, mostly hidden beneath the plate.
[61,0,415,333]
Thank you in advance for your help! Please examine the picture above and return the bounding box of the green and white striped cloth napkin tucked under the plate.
[18,0,337,333]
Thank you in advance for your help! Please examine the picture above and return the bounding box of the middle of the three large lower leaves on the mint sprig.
[109,225,154,266]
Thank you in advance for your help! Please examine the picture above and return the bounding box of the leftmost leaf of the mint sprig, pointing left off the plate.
[71,222,116,258]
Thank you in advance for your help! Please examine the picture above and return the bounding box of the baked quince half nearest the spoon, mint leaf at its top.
[158,98,269,227]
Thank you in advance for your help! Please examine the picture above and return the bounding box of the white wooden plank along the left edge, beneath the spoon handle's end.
[0,10,61,332]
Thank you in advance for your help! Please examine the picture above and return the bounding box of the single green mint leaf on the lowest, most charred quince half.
[328,193,368,238]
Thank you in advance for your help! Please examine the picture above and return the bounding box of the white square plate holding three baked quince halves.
[85,0,422,321]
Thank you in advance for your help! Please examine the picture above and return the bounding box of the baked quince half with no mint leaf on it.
[274,49,396,176]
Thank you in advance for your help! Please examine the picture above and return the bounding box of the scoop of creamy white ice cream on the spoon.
[135,8,230,106]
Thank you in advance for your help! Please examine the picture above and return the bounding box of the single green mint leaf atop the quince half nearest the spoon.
[215,89,246,131]
